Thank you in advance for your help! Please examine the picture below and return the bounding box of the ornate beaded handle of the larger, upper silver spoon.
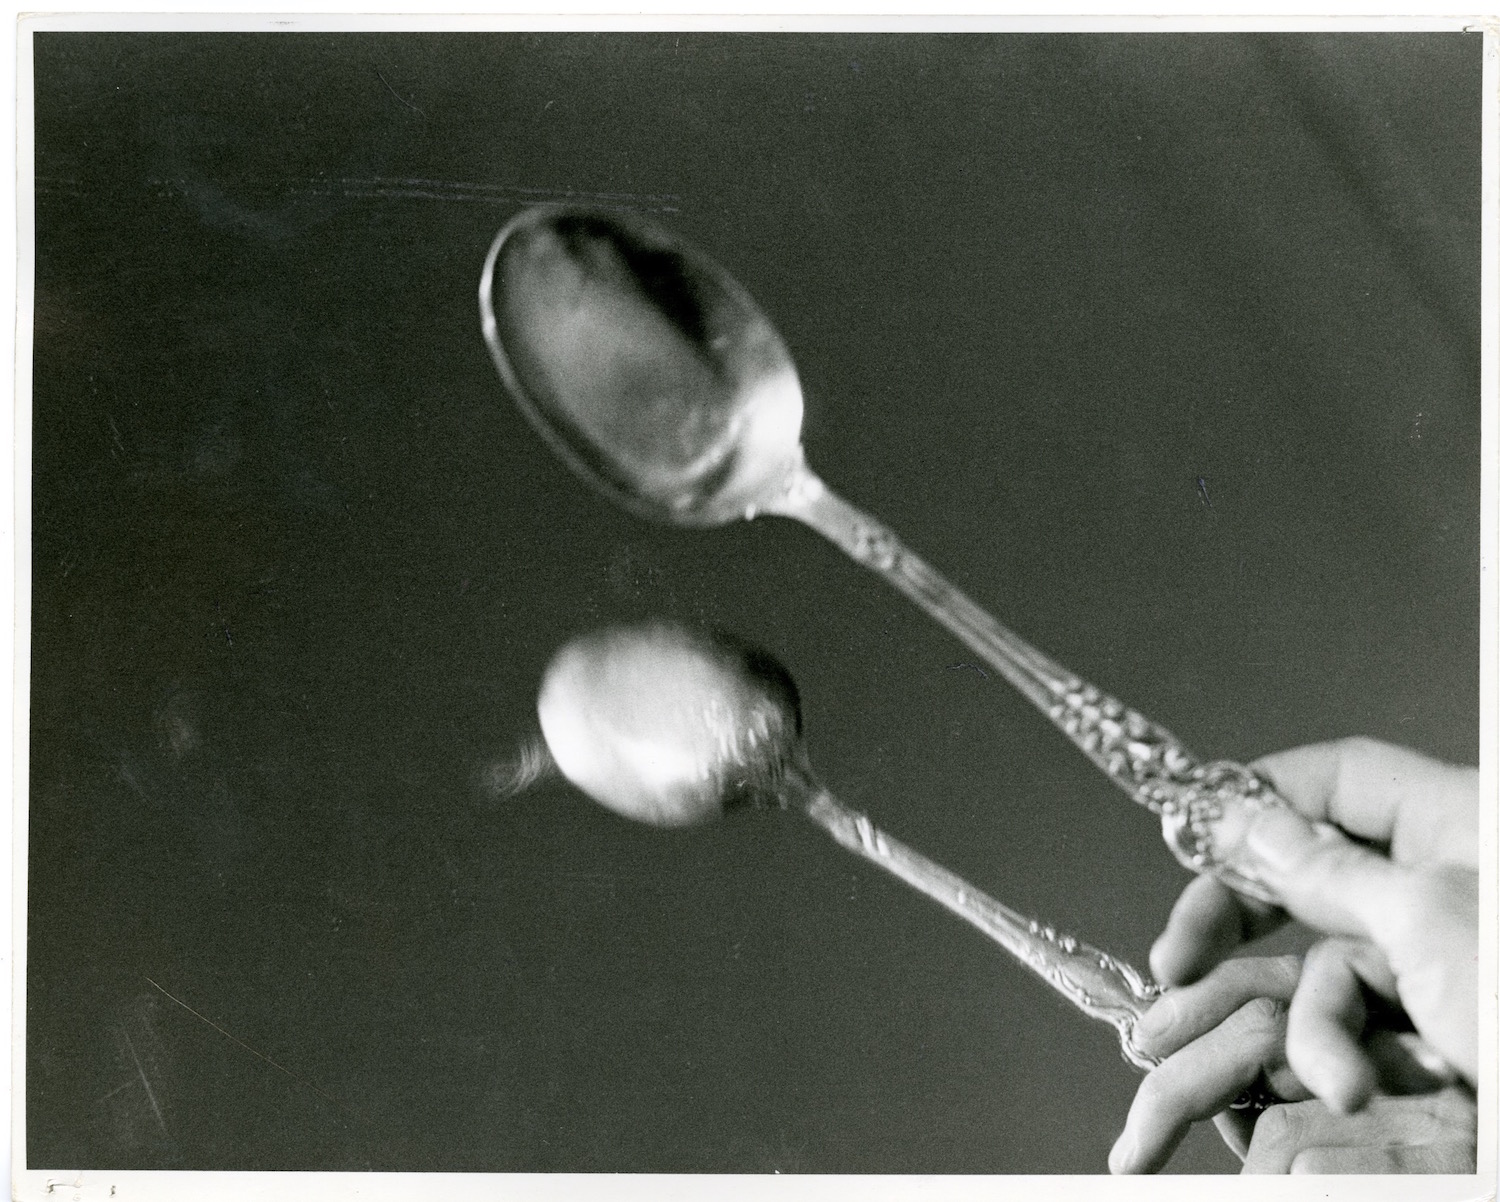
[768,468,1287,903]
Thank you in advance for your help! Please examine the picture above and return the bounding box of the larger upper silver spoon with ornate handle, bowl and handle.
[480,207,1287,903]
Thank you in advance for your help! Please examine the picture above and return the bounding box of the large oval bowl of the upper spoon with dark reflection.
[480,207,803,525]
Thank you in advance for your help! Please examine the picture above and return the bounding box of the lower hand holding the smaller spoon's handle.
[1110,956,1475,1173]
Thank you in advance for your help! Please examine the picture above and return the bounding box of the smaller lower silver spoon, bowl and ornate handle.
[537,621,1161,1068]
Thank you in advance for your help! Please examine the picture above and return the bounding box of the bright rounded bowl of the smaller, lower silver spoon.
[537,621,801,827]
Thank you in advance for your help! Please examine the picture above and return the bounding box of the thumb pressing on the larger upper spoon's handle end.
[1245,809,1409,945]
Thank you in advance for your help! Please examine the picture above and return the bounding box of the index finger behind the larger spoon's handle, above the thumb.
[1254,738,1479,864]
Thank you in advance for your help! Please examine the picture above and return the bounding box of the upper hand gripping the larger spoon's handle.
[1146,738,1479,1110]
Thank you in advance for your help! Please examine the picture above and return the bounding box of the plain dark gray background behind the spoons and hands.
[26,35,1481,1172]
